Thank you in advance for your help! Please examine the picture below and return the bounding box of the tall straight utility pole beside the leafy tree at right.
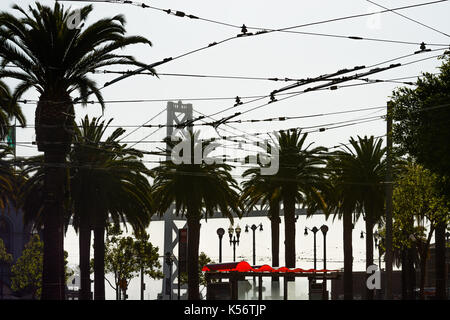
[385,101,393,300]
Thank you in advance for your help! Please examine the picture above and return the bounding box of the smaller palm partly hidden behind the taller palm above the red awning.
[241,168,281,280]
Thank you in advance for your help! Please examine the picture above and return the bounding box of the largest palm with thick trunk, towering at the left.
[0,2,155,299]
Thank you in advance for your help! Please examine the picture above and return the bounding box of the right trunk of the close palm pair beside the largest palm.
[94,214,105,300]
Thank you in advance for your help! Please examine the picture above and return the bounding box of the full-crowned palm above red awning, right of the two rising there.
[274,130,327,268]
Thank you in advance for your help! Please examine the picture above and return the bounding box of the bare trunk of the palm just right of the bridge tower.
[187,213,200,300]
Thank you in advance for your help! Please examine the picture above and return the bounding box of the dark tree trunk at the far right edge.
[435,222,447,300]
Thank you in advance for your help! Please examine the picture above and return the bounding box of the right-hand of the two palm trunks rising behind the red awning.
[283,190,295,268]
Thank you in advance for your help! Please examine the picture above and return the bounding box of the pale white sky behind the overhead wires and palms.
[0,0,450,298]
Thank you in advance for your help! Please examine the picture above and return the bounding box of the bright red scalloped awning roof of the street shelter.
[202,261,338,273]
